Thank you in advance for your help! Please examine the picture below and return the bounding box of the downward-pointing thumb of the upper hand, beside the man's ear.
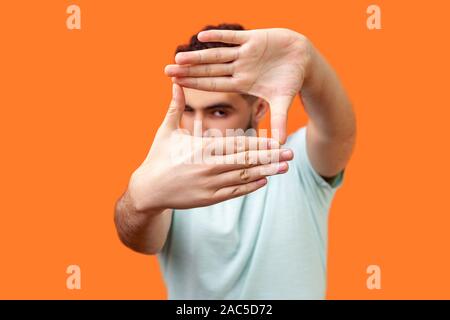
[270,96,294,144]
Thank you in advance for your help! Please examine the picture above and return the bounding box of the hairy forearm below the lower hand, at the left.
[114,191,172,254]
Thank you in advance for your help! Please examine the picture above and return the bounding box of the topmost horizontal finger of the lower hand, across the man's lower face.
[204,136,280,156]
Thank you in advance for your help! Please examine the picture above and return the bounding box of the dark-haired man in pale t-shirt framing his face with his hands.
[115,24,356,299]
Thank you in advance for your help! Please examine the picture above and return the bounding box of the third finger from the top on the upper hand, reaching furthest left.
[164,63,234,77]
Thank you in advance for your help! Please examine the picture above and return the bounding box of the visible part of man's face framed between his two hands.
[181,88,259,136]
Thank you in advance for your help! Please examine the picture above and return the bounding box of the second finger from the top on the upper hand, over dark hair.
[175,47,239,64]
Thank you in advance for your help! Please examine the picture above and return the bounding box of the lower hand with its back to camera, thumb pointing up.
[128,84,293,212]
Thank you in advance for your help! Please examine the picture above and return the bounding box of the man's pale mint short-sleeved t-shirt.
[158,127,343,299]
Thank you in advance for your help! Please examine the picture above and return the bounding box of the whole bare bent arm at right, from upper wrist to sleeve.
[301,45,356,177]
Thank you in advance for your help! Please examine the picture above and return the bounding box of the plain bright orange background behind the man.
[0,0,450,299]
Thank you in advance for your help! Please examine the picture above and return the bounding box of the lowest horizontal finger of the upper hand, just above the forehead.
[172,77,238,92]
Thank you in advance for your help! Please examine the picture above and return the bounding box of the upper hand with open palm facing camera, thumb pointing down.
[166,29,308,142]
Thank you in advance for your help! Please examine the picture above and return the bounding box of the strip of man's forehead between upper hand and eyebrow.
[183,88,245,108]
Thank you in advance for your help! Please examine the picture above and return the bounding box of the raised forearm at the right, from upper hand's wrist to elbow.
[301,43,356,141]
